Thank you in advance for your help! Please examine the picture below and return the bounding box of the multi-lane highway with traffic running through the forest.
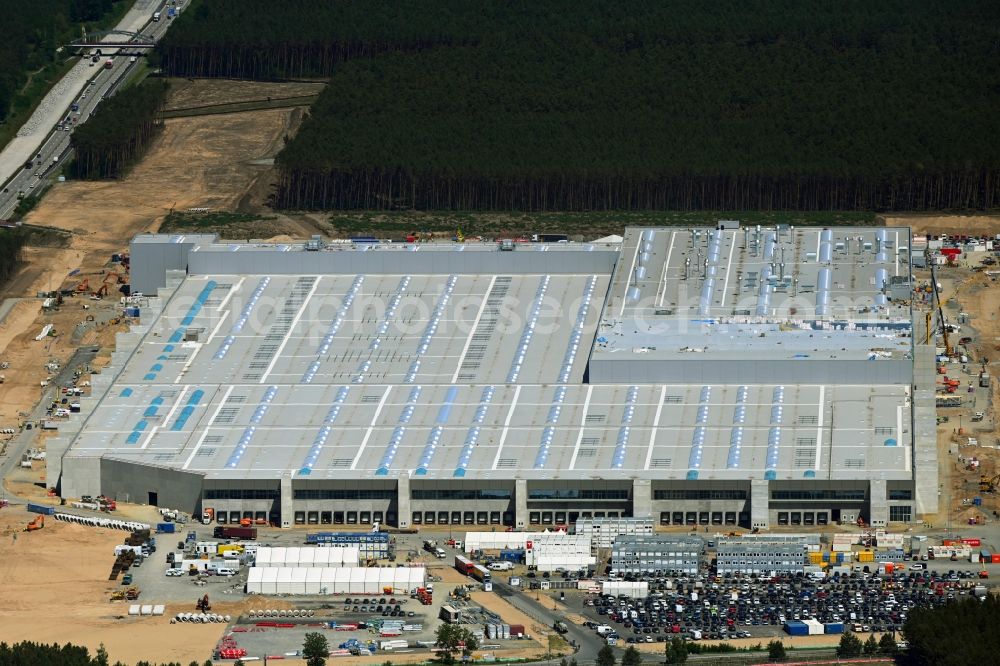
[0,0,188,220]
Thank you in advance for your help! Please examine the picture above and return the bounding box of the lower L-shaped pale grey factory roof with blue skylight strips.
[68,230,911,480]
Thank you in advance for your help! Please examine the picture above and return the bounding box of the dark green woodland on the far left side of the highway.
[0,0,120,122]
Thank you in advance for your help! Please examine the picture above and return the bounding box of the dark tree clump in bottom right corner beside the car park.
[900,594,1000,666]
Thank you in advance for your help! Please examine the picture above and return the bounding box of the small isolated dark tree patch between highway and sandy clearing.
[70,79,169,179]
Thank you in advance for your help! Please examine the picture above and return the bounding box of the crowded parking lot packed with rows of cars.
[584,571,982,643]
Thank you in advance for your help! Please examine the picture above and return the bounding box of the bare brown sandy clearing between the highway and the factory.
[0,81,316,427]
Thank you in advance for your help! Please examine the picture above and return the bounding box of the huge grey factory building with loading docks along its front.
[48,222,937,529]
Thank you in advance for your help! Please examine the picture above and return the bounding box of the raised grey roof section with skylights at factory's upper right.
[594,227,912,360]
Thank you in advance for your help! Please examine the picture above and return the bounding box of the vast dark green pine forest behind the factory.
[160,0,1000,210]
